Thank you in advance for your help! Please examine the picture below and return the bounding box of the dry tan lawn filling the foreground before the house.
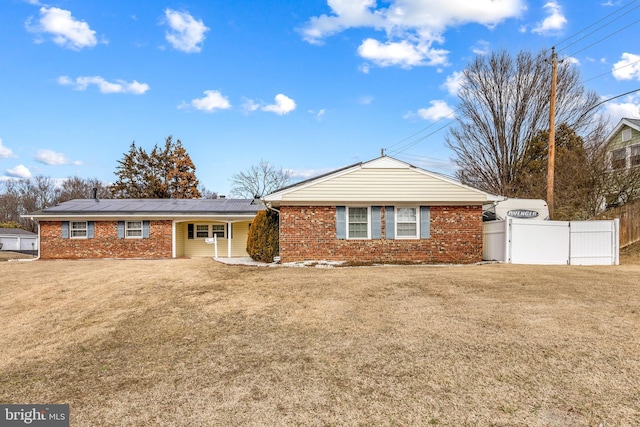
[0,258,640,426]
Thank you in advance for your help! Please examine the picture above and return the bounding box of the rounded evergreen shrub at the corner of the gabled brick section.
[247,210,279,262]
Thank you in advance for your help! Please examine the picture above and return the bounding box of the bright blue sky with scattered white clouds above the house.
[0,0,640,194]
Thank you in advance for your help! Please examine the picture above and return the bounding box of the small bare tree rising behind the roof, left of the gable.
[231,160,291,199]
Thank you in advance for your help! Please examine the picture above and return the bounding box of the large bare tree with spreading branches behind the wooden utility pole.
[446,51,598,196]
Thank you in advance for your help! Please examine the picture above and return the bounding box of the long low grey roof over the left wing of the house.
[31,199,265,216]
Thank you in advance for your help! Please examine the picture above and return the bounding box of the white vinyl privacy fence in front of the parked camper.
[482,218,620,265]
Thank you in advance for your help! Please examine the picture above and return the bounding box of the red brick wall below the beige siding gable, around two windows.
[280,206,482,263]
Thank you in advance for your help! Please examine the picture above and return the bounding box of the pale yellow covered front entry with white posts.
[173,219,251,258]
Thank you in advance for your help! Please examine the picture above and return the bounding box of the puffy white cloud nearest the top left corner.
[26,7,98,50]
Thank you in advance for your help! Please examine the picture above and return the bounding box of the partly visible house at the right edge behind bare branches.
[603,118,640,208]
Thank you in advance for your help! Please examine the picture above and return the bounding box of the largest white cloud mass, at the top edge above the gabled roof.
[300,0,526,68]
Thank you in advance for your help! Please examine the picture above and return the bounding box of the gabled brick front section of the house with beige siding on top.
[263,156,502,263]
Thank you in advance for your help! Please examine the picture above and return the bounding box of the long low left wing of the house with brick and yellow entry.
[25,199,264,259]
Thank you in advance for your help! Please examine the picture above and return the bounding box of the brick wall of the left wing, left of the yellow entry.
[40,220,171,259]
